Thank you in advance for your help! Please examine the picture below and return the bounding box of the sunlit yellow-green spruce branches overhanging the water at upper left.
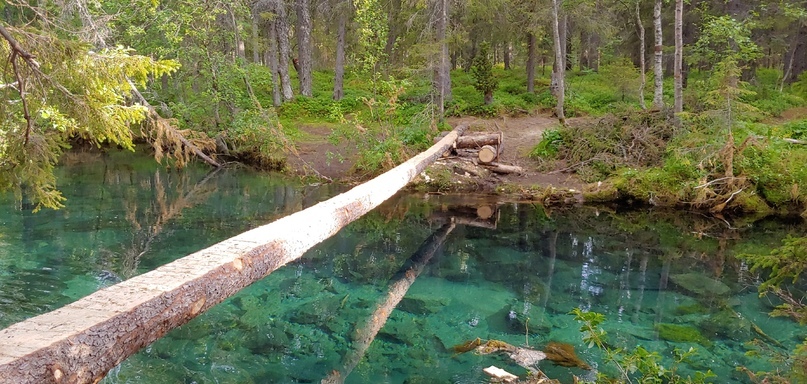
[0,28,179,210]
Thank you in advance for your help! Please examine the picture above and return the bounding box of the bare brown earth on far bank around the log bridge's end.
[289,115,584,194]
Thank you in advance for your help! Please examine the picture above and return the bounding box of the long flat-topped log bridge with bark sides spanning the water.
[0,125,468,384]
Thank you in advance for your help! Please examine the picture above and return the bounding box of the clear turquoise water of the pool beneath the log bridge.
[0,149,807,383]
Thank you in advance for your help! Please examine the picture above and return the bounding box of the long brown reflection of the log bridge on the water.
[321,222,455,384]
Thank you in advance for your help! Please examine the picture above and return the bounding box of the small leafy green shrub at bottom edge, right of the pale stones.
[571,308,716,384]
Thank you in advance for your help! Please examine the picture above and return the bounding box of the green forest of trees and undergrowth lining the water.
[0,0,807,382]
